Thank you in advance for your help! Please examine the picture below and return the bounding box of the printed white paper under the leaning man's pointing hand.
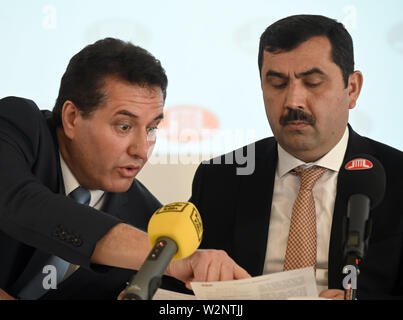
[154,267,318,300]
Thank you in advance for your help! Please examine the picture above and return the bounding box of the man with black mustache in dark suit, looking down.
[190,15,403,299]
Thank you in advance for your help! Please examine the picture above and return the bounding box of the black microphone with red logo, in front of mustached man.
[340,154,386,265]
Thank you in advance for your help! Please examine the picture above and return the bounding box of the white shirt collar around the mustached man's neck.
[277,127,349,177]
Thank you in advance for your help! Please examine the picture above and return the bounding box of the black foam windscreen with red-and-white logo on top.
[339,154,386,209]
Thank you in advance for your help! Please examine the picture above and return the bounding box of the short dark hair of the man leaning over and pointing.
[53,38,168,127]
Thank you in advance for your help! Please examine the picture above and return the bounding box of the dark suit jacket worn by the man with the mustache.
[189,127,403,299]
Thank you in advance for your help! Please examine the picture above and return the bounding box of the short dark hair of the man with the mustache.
[258,15,354,87]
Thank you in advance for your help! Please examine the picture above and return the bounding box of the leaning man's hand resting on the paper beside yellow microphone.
[166,250,250,290]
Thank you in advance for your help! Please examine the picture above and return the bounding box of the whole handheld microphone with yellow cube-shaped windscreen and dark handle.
[122,202,203,300]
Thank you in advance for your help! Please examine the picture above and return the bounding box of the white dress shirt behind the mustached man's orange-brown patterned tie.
[263,128,349,293]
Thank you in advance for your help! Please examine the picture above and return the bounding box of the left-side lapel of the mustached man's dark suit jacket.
[234,138,277,276]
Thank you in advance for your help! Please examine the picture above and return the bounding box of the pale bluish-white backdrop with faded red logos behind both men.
[0,0,403,161]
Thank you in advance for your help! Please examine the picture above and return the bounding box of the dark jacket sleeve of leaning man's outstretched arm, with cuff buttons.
[0,97,121,268]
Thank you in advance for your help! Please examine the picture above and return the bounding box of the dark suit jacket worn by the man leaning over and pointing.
[0,97,161,299]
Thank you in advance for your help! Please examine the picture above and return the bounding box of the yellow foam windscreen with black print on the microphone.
[148,202,203,259]
